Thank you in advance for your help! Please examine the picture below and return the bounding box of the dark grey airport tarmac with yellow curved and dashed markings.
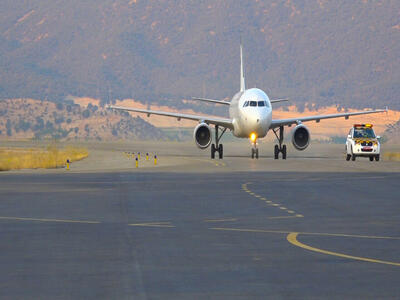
[0,143,400,299]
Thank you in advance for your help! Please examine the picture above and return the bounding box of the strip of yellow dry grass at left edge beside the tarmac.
[0,146,89,171]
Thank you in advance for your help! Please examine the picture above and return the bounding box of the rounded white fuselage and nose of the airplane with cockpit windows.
[229,88,272,138]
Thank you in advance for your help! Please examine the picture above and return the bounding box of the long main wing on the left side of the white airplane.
[107,105,233,129]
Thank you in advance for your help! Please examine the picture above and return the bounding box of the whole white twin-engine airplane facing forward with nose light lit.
[108,45,387,159]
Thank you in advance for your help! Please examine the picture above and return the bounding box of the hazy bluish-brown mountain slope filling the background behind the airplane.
[0,0,400,109]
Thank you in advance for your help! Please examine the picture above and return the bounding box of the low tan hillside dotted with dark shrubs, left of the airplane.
[0,99,164,140]
